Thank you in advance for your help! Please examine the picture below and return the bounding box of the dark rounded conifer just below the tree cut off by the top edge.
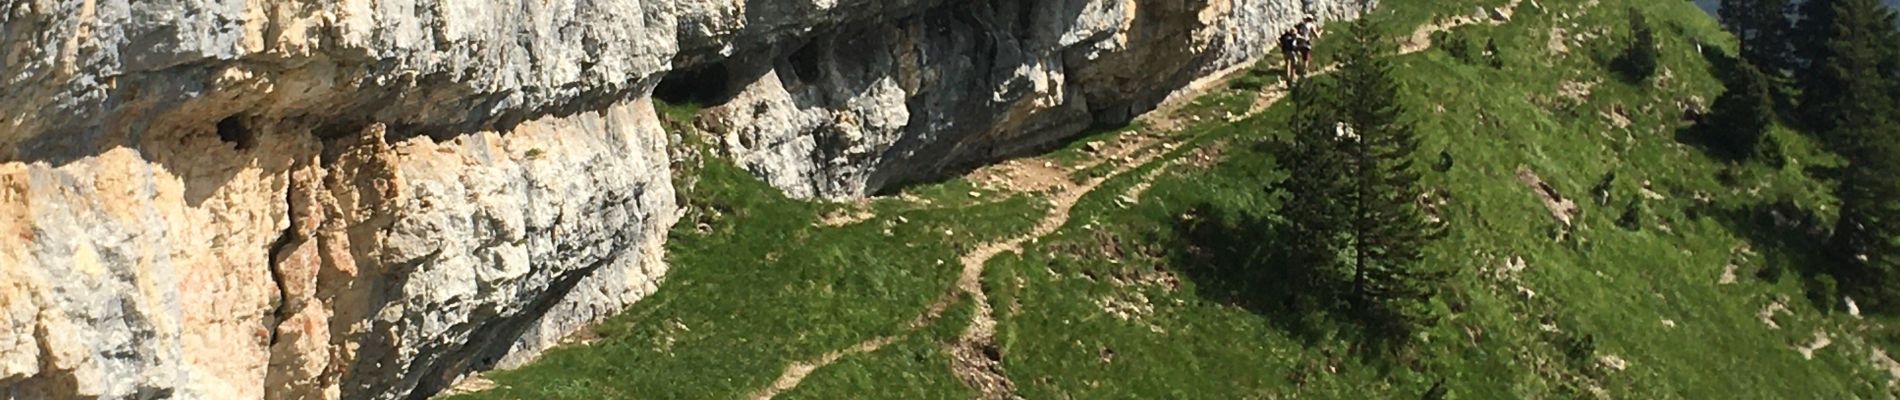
[1706,59,1775,159]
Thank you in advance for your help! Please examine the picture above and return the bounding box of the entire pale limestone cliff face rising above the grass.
[0,0,1357,398]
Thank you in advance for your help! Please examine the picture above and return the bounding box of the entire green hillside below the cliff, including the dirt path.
[466,0,1900,398]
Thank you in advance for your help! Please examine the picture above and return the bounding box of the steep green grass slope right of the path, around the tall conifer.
[992,0,1885,398]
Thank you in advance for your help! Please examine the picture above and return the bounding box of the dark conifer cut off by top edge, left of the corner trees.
[1721,0,1794,76]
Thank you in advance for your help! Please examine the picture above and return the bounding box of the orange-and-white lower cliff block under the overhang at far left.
[0,97,675,398]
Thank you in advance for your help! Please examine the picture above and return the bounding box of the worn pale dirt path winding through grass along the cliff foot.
[751,0,1522,398]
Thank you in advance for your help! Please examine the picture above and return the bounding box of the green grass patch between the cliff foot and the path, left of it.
[466,104,1041,398]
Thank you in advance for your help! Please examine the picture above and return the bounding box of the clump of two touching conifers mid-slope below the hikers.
[1281,15,1448,345]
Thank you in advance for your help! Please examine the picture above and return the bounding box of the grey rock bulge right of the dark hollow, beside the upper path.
[701,0,1359,197]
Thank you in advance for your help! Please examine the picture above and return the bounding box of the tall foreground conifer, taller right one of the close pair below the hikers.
[1338,19,1448,339]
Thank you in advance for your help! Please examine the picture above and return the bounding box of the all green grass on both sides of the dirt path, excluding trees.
[456,0,1885,398]
